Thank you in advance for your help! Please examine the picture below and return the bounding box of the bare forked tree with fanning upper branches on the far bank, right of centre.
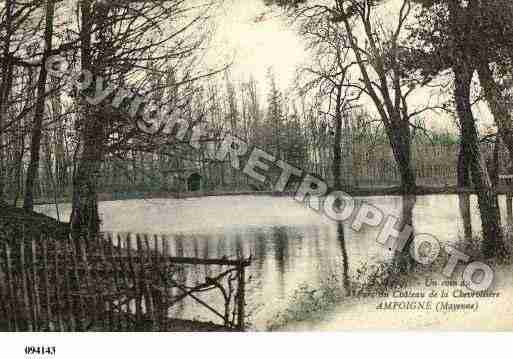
[269,0,440,197]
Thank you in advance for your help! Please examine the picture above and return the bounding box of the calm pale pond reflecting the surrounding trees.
[37,195,505,329]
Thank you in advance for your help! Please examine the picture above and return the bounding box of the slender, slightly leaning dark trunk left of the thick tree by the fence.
[23,0,54,211]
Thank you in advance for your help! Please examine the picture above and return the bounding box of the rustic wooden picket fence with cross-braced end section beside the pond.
[0,228,249,331]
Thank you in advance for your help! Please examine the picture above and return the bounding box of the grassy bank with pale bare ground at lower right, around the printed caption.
[266,236,513,331]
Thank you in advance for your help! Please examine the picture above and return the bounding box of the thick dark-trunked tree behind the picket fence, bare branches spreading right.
[70,0,218,233]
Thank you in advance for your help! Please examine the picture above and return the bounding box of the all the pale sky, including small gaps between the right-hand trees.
[209,0,492,131]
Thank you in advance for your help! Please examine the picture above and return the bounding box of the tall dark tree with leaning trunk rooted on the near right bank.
[414,0,510,257]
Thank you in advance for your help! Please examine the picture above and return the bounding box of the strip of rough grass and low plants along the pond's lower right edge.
[266,228,513,331]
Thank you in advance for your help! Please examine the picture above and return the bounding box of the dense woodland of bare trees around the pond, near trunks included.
[0,0,513,262]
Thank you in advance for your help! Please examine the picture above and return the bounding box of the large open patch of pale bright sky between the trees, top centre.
[207,0,306,88]
